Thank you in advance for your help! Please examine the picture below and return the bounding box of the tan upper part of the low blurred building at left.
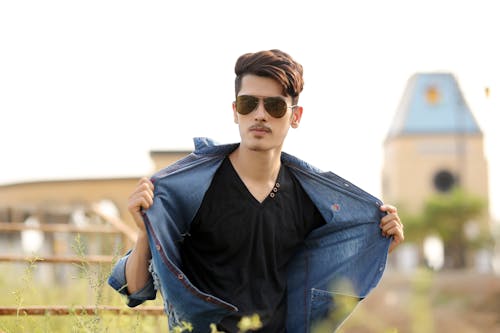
[0,151,190,236]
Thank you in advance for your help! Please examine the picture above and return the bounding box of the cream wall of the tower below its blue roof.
[382,134,488,212]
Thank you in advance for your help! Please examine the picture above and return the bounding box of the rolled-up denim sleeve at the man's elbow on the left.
[108,251,156,308]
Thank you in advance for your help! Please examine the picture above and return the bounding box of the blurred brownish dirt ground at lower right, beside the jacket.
[341,270,500,333]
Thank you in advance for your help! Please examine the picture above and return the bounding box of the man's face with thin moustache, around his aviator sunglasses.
[233,74,302,151]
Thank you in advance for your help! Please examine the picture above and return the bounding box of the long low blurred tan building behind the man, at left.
[0,151,190,284]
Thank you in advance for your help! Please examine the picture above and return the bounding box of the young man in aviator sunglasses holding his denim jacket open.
[109,50,404,333]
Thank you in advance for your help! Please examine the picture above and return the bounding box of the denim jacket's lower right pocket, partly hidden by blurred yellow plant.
[309,288,360,332]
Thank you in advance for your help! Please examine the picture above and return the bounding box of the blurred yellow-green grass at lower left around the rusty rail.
[0,236,168,333]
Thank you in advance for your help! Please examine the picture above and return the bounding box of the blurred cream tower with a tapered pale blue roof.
[382,72,488,213]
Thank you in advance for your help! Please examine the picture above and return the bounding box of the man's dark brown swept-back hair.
[234,50,304,104]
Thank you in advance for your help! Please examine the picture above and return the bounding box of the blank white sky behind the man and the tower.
[0,0,500,218]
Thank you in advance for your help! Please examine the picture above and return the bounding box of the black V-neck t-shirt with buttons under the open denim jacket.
[181,158,325,333]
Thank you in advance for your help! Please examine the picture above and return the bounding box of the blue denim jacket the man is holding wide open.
[108,138,390,333]
